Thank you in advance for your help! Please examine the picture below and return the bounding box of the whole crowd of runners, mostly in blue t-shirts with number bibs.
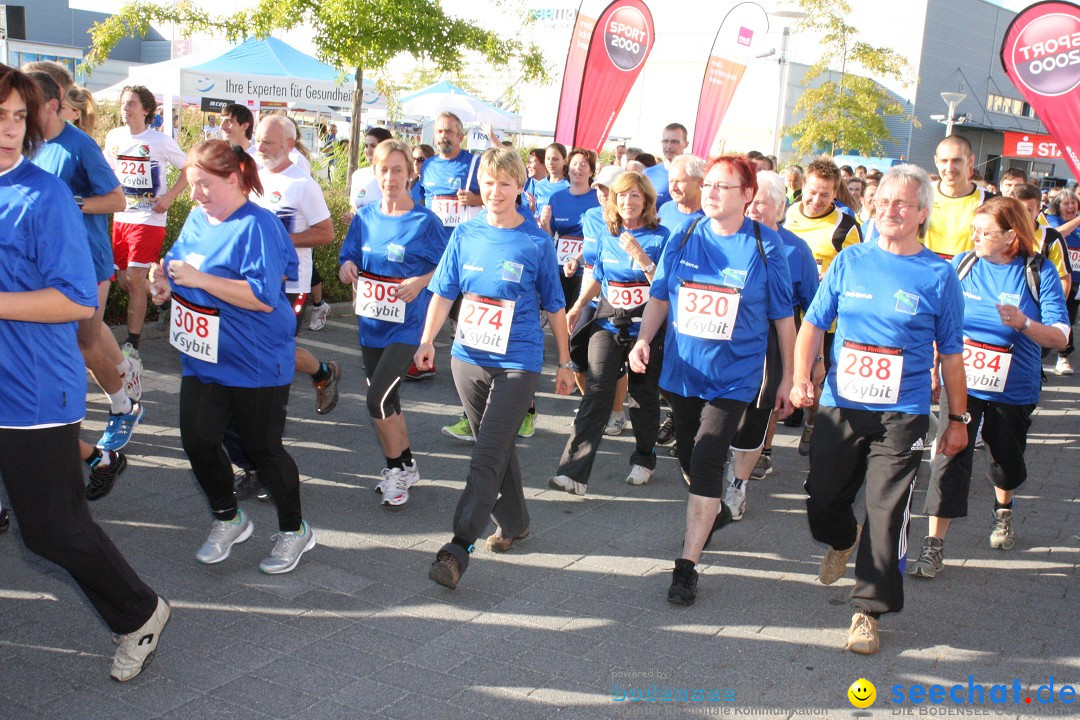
[0,63,1080,681]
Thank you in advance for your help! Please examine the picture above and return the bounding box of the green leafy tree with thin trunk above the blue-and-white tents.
[83,0,548,185]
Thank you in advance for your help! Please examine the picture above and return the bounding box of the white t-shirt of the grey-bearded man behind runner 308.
[251,165,330,293]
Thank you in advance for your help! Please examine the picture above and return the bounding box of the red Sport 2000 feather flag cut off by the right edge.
[1001,0,1080,178]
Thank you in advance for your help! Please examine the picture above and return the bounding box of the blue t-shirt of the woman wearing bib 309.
[339,203,450,348]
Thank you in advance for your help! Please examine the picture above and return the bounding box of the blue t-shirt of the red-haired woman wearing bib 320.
[649,218,792,403]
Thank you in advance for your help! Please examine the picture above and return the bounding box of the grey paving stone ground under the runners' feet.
[0,307,1080,720]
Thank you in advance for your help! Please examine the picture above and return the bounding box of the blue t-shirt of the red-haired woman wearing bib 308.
[164,201,299,388]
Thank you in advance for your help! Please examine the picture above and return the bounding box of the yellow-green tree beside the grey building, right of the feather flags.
[784,0,914,155]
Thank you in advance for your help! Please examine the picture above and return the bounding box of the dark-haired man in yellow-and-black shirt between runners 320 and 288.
[784,158,863,456]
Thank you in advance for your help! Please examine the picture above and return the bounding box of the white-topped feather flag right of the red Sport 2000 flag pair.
[693,2,769,158]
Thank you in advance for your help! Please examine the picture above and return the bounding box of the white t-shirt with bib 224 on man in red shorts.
[105,125,188,227]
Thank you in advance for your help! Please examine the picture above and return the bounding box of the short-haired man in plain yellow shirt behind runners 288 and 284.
[922,135,993,260]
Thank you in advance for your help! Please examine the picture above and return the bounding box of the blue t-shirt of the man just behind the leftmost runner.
[32,123,120,283]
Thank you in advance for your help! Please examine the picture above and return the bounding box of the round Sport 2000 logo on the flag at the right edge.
[1010,13,1080,97]
